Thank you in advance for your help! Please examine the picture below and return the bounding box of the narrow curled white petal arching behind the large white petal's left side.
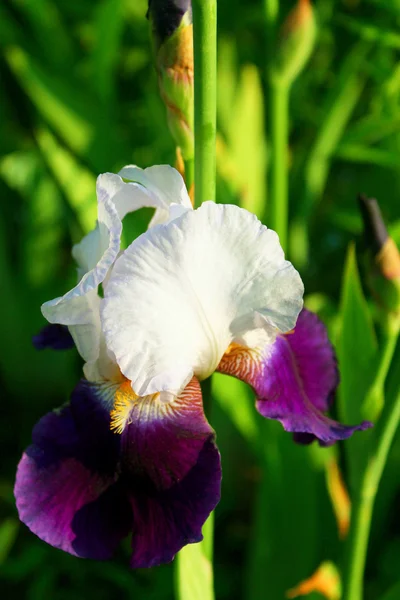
[42,166,191,381]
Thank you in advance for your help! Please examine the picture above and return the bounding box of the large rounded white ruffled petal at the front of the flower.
[102,202,303,396]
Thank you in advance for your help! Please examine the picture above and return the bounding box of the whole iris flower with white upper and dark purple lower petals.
[15,166,369,567]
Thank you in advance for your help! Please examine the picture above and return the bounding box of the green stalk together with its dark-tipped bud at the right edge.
[343,196,400,600]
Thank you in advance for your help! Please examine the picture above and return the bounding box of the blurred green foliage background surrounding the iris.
[0,0,400,600]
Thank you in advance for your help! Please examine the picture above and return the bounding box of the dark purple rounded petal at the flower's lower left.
[14,382,132,560]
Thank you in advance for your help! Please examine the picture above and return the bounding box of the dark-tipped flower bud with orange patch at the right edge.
[359,195,400,320]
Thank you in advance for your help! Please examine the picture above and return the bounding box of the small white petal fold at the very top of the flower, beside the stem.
[119,165,192,227]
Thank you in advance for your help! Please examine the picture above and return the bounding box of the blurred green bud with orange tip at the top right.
[276,0,316,84]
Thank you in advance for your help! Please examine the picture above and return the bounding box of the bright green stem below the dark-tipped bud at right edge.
[343,332,400,600]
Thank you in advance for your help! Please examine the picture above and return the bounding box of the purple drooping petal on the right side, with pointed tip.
[219,309,371,446]
